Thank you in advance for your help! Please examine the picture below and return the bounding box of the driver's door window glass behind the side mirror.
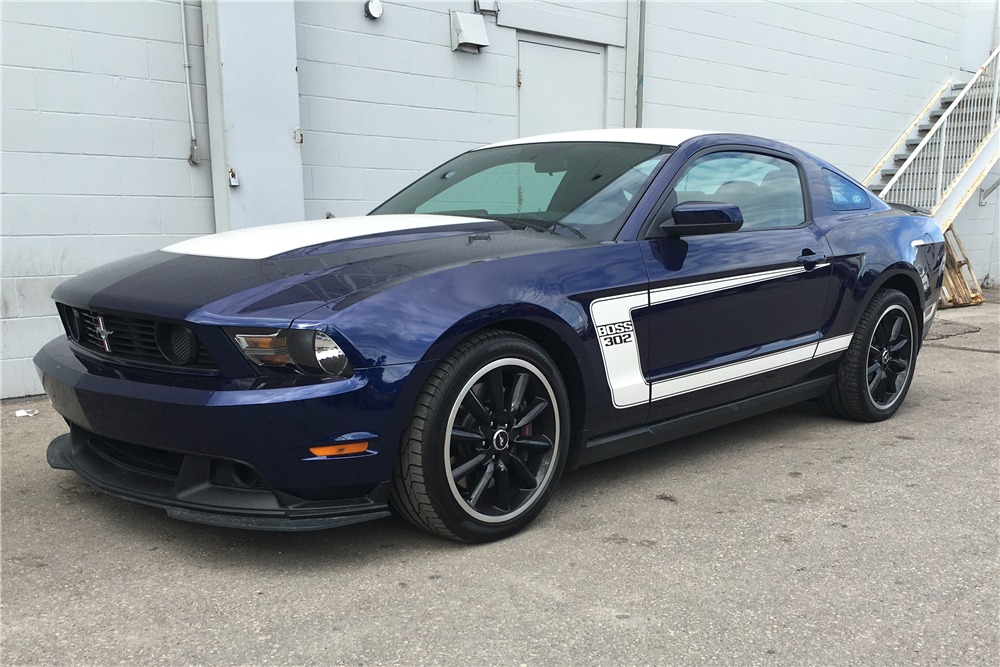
[665,151,805,229]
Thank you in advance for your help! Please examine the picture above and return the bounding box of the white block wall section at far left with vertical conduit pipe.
[0,0,214,397]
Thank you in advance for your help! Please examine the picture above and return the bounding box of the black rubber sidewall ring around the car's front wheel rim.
[421,334,570,542]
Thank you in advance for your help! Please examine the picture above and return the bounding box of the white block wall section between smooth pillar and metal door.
[295,2,517,218]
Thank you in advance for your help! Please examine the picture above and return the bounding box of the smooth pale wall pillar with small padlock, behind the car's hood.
[203,0,304,232]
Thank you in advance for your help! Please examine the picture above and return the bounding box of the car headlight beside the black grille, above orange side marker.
[225,327,354,378]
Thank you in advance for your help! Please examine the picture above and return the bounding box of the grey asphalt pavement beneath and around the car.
[0,290,1000,667]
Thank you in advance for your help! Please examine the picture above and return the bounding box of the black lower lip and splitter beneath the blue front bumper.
[46,426,389,531]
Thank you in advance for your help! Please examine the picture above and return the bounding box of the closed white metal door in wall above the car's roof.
[517,40,605,137]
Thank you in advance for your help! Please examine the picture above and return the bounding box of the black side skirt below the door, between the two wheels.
[577,375,834,466]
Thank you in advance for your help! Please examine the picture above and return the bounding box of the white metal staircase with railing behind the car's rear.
[866,48,1000,307]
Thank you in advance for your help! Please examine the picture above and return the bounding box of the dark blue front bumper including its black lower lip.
[35,339,429,530]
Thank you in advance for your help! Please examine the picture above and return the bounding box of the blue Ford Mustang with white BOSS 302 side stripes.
[35,129,945,542]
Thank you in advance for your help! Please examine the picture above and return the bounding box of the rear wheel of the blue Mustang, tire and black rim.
[821,289,919,422]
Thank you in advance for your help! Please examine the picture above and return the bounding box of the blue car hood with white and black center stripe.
[53,215,594,326]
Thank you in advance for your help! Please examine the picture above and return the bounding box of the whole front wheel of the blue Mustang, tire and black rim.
[390,330,570,542]
